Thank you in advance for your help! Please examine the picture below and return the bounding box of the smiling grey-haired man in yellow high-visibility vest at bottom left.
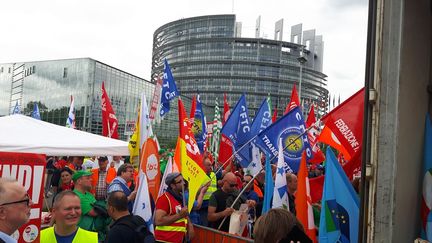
[40,191,98,243]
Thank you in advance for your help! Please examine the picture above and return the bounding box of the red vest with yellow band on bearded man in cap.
[155,192,187,243]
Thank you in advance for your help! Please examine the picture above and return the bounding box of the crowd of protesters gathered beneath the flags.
[0,150,334,243]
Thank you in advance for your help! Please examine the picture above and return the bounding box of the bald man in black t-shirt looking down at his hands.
[207,172,255,232]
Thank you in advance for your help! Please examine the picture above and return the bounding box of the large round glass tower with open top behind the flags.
[151,14,328,119]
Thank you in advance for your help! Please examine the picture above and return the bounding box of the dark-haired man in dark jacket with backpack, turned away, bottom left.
[105,191,154,243]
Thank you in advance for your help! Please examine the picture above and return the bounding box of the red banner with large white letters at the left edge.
[0,152,46,243]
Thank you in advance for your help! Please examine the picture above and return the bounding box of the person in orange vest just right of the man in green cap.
[91,157,116,201]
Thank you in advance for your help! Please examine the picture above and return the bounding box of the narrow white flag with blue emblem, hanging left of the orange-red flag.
[272,139,289,210]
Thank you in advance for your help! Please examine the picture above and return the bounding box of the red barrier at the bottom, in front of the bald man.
[191,224,254,243]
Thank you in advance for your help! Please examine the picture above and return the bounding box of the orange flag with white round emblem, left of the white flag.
[140,138,160,202]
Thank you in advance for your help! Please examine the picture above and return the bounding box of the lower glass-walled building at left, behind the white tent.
[0,58,154,140]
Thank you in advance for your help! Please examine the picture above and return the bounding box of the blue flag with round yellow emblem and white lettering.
[256,107,312,173]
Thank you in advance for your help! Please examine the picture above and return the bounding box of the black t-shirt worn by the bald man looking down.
[209,189,247,232]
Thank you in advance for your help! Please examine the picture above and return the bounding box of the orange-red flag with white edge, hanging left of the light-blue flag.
[295,152,317,242]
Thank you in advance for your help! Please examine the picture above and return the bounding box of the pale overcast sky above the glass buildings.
[0,0,367,100]
